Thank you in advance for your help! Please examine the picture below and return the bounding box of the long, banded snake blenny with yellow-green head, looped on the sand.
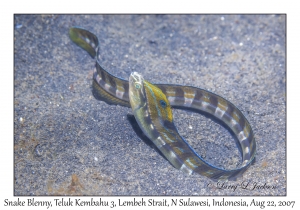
[69,27,256,180]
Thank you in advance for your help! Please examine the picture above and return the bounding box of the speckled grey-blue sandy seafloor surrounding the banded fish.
[13,15,287,196]
